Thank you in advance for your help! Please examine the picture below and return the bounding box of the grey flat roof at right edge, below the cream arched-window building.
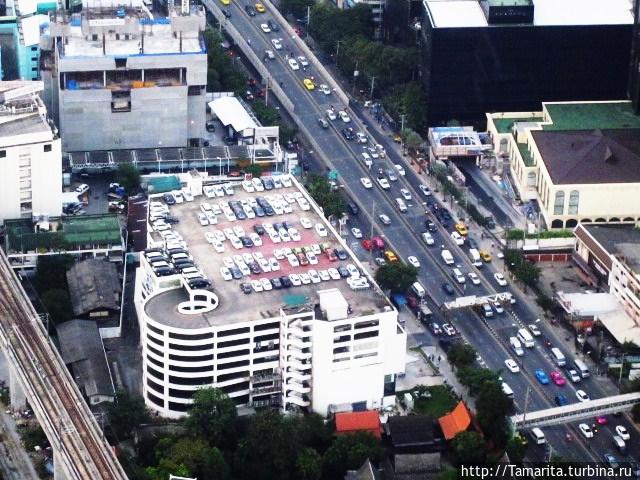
[583,225,640,274]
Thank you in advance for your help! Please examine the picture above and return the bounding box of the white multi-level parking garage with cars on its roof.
[135,176,406,417]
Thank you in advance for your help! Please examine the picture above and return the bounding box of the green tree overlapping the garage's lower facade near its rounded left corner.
[185,388,237,448]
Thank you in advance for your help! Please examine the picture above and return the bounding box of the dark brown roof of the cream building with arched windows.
[531,128,640,185]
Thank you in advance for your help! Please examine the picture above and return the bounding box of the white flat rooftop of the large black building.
[424,0,633,28]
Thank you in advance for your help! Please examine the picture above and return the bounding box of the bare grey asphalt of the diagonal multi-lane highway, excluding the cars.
[205,0,640,460]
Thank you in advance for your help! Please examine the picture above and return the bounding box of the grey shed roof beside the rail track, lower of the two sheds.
[56,320,115,397]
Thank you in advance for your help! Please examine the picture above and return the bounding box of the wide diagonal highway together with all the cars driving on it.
[205,0,640,461]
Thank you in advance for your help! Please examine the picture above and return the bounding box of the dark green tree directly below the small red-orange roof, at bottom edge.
[322,432,383,478]
